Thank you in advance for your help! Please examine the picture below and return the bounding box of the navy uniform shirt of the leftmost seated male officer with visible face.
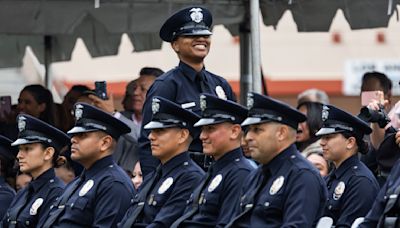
[43,155,134,227]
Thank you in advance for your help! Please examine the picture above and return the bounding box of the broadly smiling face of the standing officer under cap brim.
[172,36,211,63]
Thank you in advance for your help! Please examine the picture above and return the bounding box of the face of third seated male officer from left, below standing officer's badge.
[200,123,236,160]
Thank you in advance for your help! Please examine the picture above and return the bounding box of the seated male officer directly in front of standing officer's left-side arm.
[119,96,204,227]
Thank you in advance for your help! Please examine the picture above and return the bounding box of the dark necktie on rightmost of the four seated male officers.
[225,166,271,227]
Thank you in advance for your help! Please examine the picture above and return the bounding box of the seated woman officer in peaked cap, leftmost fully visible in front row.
[2,114,69,227]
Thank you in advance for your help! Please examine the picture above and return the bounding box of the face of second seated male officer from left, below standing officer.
[149,127,185,164]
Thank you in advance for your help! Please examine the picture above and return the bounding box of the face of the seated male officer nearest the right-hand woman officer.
[245,122,280,164]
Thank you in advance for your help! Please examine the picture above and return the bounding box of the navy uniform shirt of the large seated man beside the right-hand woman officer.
[231,145,327,228]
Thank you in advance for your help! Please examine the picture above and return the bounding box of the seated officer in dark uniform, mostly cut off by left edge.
[0,135,18,219]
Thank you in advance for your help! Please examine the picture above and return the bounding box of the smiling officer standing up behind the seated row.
[139,7,235,175]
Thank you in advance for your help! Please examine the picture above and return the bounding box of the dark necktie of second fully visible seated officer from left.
[43,171,85,228]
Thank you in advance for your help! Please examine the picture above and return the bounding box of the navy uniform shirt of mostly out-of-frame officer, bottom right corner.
[359,160,400,228]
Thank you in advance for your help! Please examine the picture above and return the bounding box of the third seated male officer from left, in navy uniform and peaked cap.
[172,95,253,227]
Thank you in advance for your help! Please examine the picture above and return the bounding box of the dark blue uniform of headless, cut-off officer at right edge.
[359,161,400,228]
